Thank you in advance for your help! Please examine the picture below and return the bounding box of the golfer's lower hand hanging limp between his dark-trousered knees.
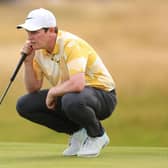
[46,88,56,110]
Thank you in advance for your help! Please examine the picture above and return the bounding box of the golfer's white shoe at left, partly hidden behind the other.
[63,128,87,156]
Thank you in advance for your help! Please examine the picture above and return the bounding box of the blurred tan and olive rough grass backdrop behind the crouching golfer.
[0,0,168,146]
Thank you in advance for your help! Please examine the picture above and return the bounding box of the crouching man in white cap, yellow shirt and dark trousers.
[16,8,117,157]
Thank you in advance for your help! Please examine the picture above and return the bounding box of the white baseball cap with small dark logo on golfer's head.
[17,8,56,31]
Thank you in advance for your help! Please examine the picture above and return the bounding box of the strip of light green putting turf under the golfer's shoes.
[0,143,168,168]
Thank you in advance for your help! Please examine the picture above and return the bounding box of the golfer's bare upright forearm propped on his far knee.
[24,62,42,93]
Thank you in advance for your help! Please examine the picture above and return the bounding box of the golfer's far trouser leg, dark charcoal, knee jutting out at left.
[16,90,79,134]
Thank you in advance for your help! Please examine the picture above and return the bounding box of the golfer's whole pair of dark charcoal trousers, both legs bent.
[16,87,117,137]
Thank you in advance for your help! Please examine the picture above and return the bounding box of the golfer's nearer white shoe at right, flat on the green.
[77,133,110,157]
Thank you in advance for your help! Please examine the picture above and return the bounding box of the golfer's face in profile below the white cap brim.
[27,29,48,50]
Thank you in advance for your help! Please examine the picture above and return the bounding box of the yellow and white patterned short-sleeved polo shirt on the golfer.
[33,31,115,91]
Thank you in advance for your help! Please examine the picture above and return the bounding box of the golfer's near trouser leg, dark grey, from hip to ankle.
[62,87,116,137]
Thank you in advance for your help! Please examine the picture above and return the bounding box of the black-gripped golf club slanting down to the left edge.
[0,52,27,104]
